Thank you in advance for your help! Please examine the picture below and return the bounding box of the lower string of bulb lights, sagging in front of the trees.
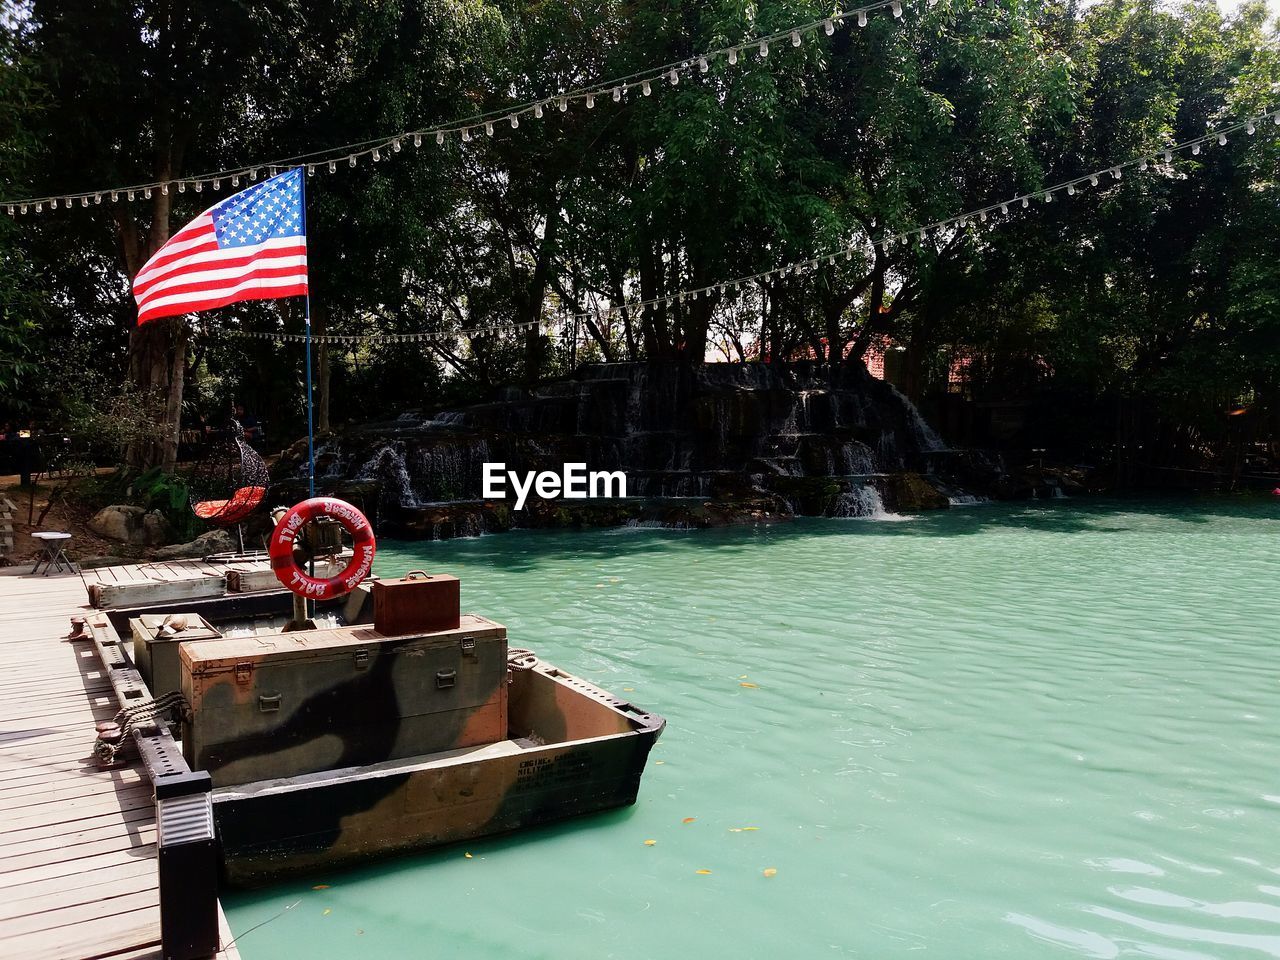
[228,109,1280,346]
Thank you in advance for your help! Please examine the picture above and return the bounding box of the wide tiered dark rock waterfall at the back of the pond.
[300,364,977,538]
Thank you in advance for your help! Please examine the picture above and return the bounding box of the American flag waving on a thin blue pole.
[133,169,307,324]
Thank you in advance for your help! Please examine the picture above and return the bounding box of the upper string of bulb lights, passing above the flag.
[0,0,921,216]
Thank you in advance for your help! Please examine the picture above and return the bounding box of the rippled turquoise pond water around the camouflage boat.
[224,499,1280,960]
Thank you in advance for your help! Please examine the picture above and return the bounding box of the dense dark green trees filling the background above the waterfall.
[0,0,1280,473]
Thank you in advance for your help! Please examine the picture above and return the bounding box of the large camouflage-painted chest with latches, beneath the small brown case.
[180,614,507,786]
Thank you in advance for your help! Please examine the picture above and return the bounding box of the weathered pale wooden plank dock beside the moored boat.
[0,562,238,960]
